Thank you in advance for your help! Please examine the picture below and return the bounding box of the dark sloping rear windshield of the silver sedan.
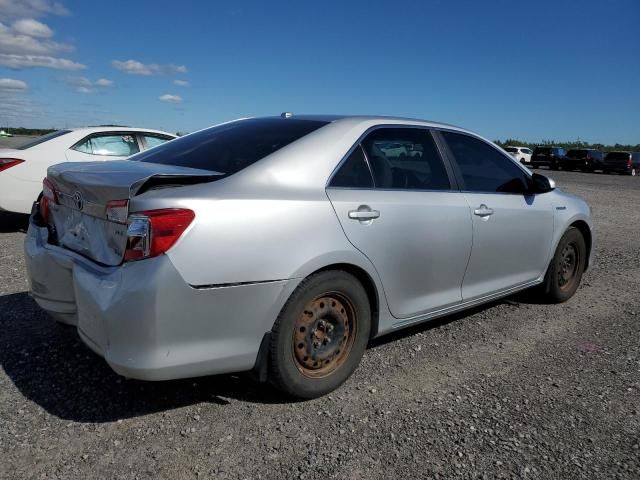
[132,118,328,175]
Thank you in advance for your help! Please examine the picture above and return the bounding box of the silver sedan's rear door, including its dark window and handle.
[327,127,471,318]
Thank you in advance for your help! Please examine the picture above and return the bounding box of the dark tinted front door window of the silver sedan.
[442,132,529,193]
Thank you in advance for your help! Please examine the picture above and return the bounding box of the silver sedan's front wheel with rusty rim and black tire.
[542,227,587,303]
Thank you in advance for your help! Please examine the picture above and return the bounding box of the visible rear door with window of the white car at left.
[66,131,141,162]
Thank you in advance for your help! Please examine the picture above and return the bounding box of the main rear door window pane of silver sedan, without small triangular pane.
[362,128,451,190]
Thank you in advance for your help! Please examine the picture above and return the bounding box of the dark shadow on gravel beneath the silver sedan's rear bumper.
[0,292,290,423]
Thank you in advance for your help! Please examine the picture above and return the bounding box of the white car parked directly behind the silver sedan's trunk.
[0,127,176,213]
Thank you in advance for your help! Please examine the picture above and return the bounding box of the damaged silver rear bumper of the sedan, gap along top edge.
[25,220,297,380]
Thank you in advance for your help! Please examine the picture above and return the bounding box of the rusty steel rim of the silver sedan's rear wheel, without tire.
[293,292,358,378]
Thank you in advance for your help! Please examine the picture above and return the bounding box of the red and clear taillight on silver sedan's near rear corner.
[124,208,196,261]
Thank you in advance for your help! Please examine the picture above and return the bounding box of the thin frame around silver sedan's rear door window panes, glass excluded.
[324,123,460,193]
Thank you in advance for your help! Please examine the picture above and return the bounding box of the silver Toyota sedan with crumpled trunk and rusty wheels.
[25,115,593,398]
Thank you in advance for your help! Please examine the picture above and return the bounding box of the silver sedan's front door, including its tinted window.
[440,131,553,301]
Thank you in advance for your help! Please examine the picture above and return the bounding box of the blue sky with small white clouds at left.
[0,0,640,144]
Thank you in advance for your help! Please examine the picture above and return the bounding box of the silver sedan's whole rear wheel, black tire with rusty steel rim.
[269,270,371,399]
